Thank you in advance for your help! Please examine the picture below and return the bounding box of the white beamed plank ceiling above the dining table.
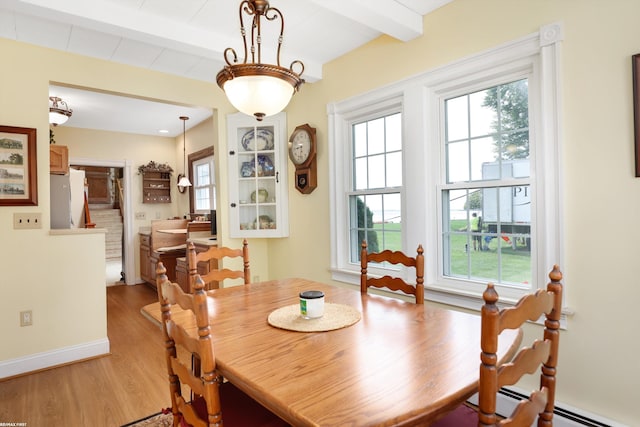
[0,0,453,134]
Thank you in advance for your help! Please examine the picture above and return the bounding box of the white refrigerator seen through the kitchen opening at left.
[49,168,84,229]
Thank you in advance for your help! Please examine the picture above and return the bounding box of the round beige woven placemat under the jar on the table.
[267,303,361,332]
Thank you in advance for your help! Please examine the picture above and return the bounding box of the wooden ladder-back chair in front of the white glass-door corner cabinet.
[187,239,251,291]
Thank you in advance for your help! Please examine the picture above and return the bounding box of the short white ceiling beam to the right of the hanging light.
[309,0,423,42]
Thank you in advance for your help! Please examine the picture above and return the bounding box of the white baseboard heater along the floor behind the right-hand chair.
[469,387,629,427]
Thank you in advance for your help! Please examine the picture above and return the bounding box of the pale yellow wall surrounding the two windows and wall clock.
[278,0,640,425]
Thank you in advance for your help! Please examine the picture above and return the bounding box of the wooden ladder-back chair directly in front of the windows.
[360,240,424,304]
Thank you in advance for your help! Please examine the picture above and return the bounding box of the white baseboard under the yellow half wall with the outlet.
[0,338,110,378]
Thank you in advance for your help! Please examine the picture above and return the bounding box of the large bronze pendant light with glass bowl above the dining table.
[216,0,304,121]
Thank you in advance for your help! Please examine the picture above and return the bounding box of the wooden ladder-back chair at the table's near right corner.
[433,265,562,427]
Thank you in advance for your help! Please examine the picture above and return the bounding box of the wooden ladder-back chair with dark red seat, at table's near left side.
[156,262,287,427]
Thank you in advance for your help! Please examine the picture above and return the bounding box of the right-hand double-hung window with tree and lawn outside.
[442,78,532,285]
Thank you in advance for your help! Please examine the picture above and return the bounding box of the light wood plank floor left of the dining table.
[0,285,171,427]
